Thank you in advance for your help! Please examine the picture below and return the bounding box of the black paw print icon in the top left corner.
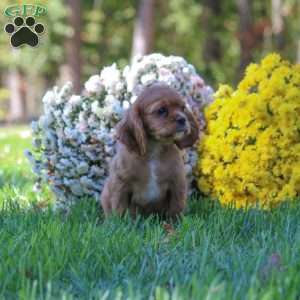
[4,16,45,48]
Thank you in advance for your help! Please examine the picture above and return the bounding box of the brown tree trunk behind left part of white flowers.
[66,0,81,93]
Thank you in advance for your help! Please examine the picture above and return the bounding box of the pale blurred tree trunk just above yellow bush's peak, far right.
[272,0,284,50]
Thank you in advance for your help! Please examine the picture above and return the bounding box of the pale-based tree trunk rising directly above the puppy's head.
[131,0,154,58]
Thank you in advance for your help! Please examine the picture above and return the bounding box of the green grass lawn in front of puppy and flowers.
[0,128,300,300]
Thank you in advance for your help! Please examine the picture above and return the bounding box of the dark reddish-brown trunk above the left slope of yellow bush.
[236,0,254,79]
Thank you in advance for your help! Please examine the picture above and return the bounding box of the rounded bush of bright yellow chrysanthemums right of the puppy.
[197,54,300,208]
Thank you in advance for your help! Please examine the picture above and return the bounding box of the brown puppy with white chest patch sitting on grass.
[101,84,199,217]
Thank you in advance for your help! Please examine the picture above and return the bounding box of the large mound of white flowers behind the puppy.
[26,54,213,208]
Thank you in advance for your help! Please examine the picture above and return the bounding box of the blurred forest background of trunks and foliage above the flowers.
[0,0,300,124]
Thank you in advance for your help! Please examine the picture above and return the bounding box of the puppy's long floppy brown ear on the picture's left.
[117,105,146,156]
